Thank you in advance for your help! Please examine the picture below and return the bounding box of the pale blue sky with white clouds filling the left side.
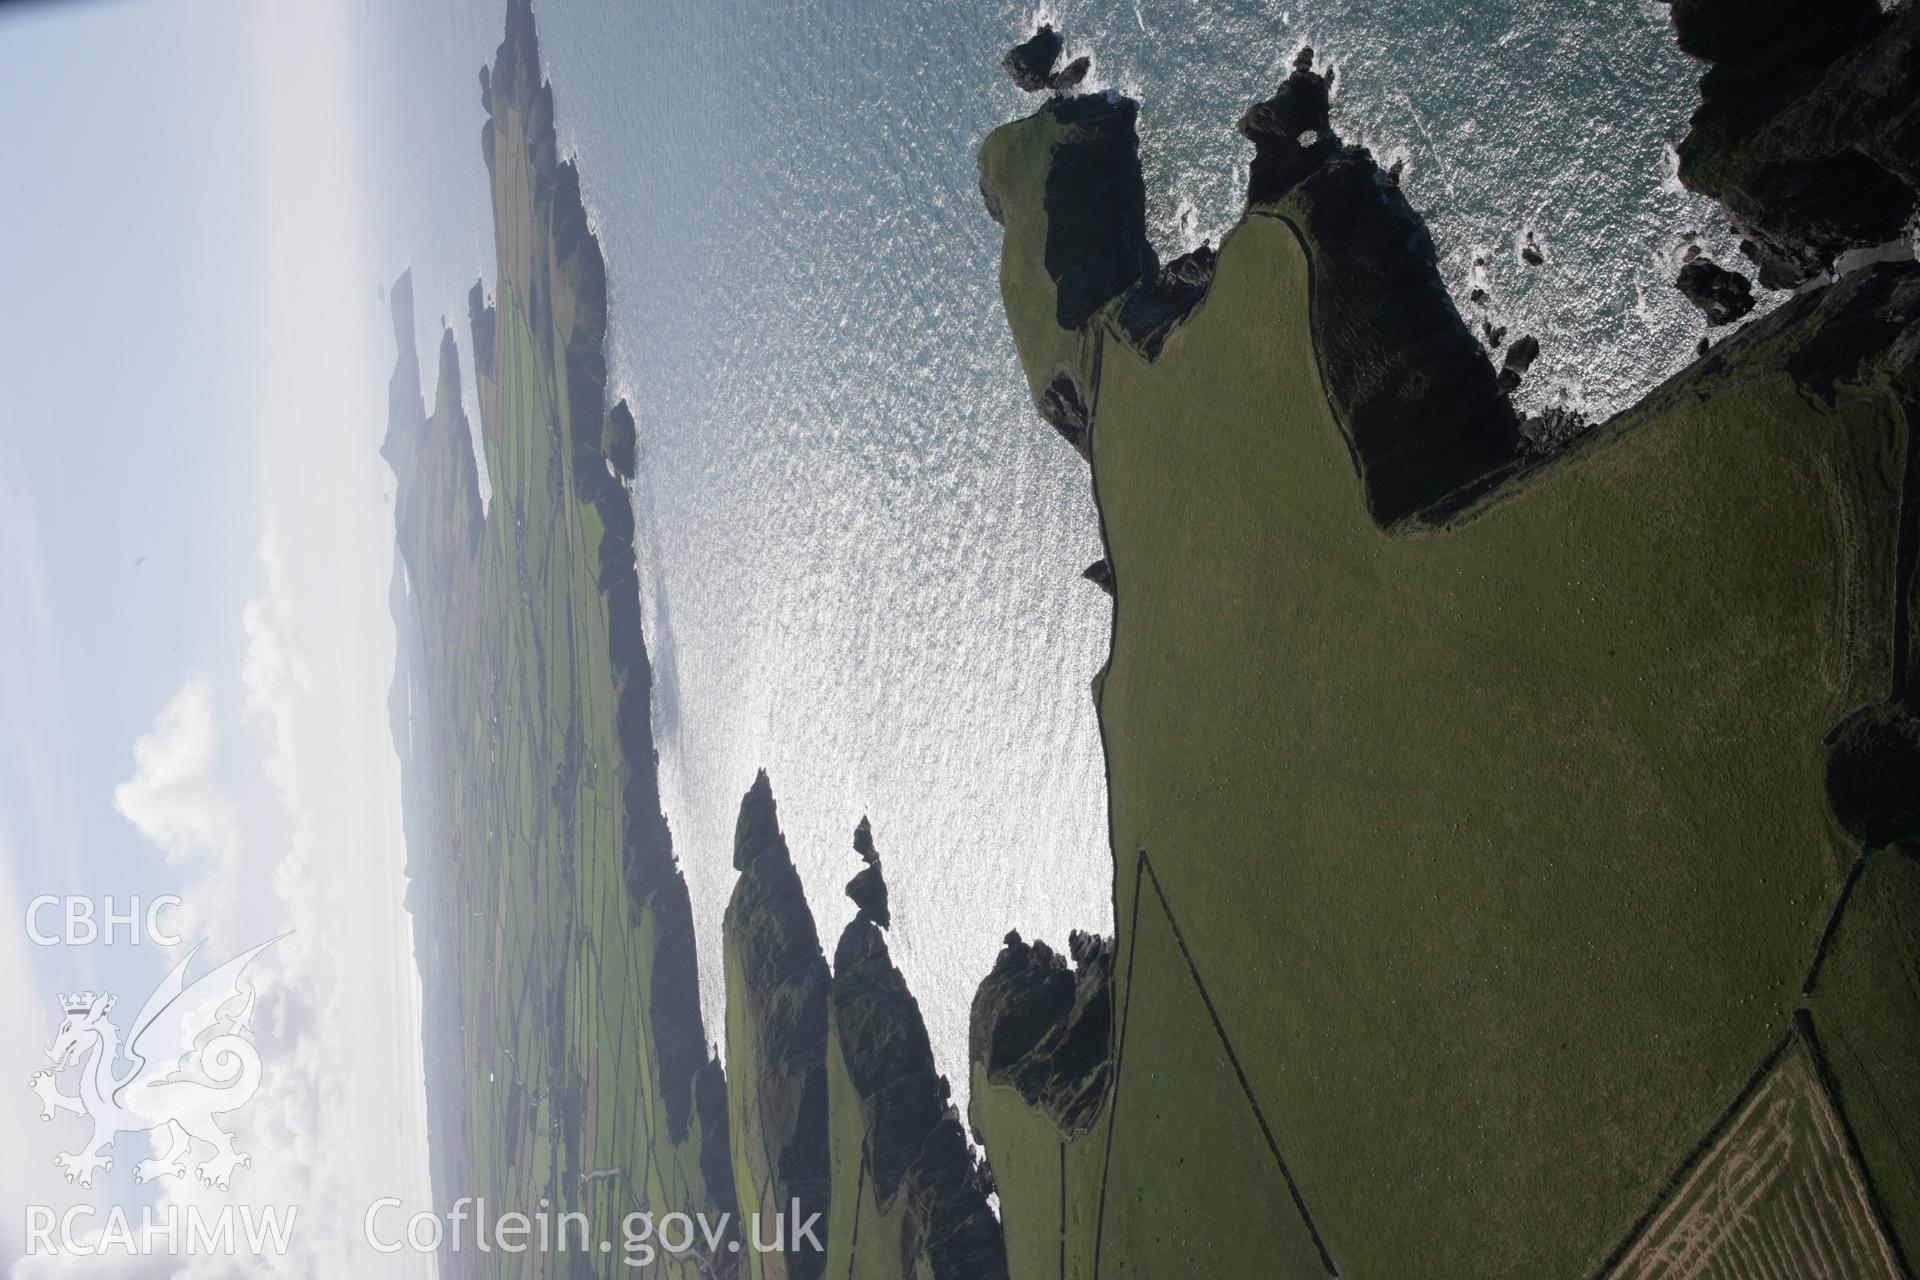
[0,0,432,1278]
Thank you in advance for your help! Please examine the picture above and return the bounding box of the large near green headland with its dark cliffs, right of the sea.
[973,12,1920,1278]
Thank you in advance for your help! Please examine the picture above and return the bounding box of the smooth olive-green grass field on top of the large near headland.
[983,105,1901,1276]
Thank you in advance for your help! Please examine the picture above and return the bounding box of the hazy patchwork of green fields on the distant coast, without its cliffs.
[437,284,725,1274]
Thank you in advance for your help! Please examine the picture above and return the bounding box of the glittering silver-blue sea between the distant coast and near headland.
[357,0,1776,1096]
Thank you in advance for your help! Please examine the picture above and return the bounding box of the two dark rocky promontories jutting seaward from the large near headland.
[981,37,1523,528]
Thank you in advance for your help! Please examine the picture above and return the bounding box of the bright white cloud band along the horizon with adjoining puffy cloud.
[0,4,434,1278]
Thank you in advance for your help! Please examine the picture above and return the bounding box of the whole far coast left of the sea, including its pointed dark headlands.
[384,0,1006,1280]
